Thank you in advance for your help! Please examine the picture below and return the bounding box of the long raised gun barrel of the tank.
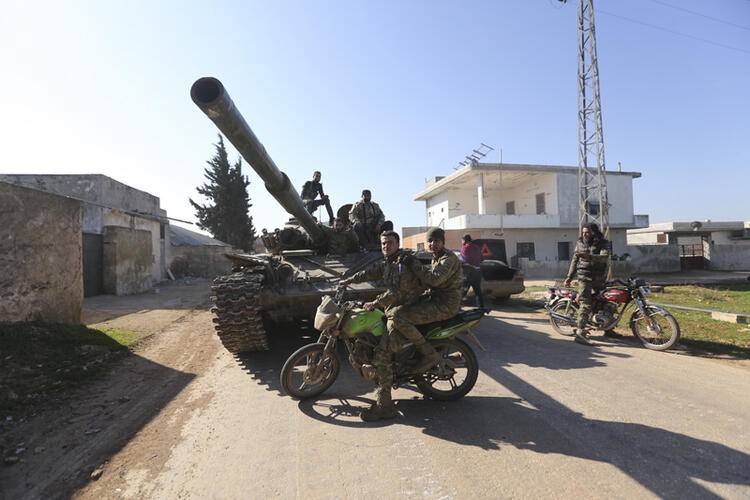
[190,77,325,244]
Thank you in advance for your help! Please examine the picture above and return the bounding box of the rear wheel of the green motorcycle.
[415,338,479,401]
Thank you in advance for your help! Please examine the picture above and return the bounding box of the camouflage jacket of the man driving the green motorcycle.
[349,249,426,312]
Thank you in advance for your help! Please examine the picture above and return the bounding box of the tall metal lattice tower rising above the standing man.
[578,0,611,241]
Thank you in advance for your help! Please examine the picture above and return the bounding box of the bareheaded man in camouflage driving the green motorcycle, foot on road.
[341,231,425,422]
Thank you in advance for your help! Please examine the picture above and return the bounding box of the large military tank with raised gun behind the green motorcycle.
[190,77,384,354]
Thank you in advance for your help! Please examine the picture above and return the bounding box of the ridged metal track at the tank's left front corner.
[211,265,270,354]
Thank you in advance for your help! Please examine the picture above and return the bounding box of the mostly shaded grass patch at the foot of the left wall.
[0,322,143,414]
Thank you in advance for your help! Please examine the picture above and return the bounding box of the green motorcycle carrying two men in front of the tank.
[281,287,485,401]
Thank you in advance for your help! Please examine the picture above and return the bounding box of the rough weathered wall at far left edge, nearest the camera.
[0,182,83,324]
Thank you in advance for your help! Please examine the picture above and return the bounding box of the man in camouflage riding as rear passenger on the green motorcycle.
[389,227,464,373]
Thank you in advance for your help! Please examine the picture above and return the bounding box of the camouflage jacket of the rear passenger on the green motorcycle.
[410,250,464,314]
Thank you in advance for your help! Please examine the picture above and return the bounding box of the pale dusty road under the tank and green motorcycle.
[0,282,750,499]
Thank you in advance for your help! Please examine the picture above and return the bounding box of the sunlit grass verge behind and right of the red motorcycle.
[511,283,750,359]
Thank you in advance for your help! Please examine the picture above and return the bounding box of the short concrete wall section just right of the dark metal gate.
[102,226,154,295]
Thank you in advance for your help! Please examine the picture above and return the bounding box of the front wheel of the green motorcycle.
[280,344,341,399]
